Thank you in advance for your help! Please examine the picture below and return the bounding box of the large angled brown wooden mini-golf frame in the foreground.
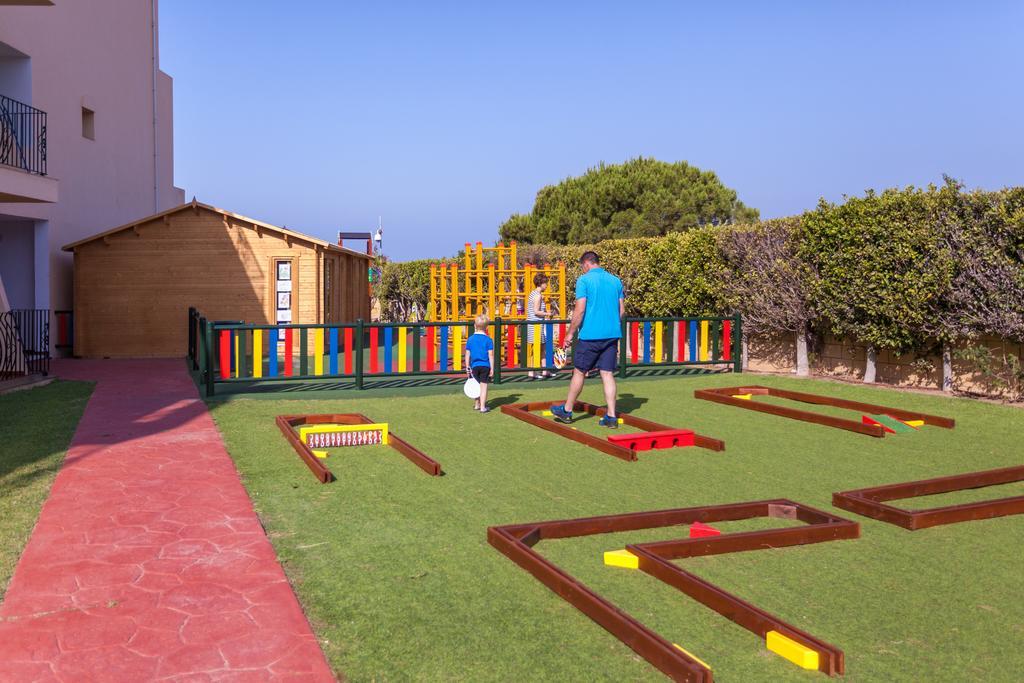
[487,499,860,683]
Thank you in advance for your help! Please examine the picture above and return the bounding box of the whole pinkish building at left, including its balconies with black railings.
[0,0,184,352]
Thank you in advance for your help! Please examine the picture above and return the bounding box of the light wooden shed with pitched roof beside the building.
[63,200,371,357]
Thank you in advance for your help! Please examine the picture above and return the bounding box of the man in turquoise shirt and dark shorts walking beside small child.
[551,251,626,429]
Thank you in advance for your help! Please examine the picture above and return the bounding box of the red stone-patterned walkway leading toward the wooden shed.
[0,360,334,681]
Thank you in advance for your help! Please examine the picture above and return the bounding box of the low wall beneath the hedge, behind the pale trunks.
[746,336,1024,395]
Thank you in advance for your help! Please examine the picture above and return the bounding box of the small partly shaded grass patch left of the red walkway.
[0,381,93,601]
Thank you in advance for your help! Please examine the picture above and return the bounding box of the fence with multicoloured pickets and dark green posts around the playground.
[188,308,741,395]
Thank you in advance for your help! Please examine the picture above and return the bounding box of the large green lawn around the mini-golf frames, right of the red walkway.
[210,375,1024,681]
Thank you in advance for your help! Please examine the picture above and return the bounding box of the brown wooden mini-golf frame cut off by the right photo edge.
[833,465,1024,531]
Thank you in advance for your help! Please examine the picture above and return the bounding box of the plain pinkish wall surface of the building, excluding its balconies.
[0,0,183,331]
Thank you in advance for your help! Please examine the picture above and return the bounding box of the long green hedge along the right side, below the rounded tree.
[377,179,1024,351]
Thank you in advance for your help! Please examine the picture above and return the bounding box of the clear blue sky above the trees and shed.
[160,0,1024,260]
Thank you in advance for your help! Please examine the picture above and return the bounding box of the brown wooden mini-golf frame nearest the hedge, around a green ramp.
[693,385,956,438]
